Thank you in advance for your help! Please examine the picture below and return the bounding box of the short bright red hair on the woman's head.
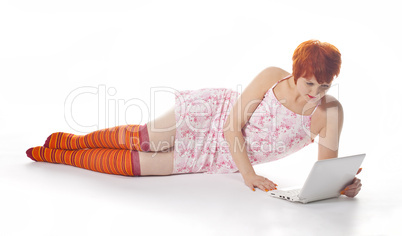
[292,40,342,84]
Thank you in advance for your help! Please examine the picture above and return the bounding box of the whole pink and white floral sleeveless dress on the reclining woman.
[173,76,317,174]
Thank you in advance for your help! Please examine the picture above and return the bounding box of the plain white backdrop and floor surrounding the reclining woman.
[0,0,402,236]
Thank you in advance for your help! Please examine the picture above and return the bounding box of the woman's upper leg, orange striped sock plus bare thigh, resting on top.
[43,107,176,152]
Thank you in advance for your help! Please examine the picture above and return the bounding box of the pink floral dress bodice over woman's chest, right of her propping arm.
[243,89,312,165]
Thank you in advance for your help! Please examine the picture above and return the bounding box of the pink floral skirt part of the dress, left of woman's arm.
[173,88,239,173]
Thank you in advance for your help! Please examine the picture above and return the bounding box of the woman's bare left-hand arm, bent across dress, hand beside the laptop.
[224,67,289,191]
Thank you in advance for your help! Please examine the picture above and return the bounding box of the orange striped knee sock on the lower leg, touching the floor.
[26,146,141,176]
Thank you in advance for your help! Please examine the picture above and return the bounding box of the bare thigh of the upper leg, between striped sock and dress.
[147,107,176,152]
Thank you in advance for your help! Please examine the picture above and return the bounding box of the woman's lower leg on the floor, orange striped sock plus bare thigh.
[26,146,174,176]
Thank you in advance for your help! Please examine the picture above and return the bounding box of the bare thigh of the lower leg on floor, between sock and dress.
[138,150,174,175]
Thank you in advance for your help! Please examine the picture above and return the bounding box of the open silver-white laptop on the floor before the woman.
[269,154,366,203]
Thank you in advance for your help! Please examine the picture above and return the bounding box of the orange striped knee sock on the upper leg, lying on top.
[43,124,150,152]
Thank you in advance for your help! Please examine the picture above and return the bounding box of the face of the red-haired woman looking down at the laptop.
[297,76,331,103]
